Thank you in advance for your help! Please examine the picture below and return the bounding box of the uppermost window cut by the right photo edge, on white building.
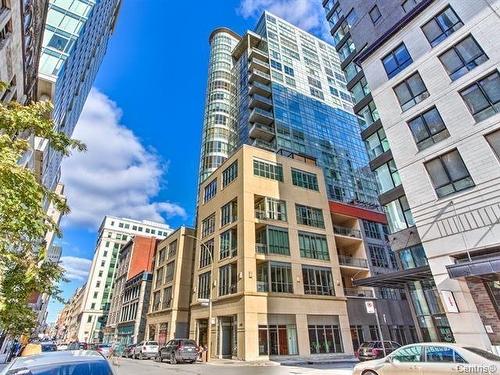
[460,70,500,121]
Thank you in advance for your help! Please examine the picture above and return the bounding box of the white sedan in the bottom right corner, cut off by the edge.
[353,343,500,375]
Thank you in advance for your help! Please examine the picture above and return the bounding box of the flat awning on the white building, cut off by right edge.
[446,254,500,281]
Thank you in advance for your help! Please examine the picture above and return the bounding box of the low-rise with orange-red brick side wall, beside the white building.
[104,235,158,344]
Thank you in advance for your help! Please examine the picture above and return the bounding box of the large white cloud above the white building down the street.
[61,89,186,229]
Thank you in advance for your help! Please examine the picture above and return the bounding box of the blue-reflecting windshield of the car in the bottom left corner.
[8,361,113,375]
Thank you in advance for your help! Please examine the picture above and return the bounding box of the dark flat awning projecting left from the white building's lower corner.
[352,266,432,289]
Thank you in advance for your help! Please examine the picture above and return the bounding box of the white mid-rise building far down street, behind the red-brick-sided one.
[78,216,171,342]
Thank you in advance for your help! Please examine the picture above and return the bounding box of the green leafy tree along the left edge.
[0,83,85,335]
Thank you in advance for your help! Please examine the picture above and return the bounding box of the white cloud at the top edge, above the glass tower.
[238,0,331,40]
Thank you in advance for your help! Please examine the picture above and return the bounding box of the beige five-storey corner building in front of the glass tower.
[190,145,353,360]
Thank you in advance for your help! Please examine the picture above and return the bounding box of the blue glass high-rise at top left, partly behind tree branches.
[36,0,121,194]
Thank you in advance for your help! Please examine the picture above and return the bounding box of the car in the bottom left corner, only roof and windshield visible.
[0,350,115,375]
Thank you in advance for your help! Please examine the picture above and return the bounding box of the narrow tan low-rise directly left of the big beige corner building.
[145,227,195,345]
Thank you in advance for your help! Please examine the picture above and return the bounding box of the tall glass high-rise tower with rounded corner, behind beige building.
[200,12,378,206]
